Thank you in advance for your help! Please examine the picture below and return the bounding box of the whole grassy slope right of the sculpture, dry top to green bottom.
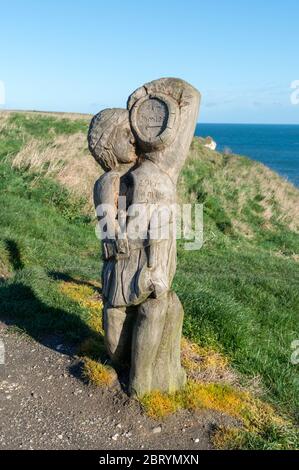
[175,142,299,414]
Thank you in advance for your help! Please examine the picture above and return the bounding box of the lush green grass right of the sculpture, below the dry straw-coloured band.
[175,242,299,416]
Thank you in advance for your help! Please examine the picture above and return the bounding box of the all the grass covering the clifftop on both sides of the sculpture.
[0,113,299,448]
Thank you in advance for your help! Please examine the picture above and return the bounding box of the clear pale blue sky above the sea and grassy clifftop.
[0,0,299,124]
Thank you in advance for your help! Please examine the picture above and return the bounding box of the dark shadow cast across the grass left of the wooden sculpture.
[0,240,107,380]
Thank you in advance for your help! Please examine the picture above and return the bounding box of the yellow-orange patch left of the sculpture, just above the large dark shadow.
[59,280,103,334]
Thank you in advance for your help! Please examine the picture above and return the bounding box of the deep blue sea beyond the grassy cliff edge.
[195,123,299,188]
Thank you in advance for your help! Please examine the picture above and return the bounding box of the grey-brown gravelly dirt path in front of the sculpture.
[0,323,233,450]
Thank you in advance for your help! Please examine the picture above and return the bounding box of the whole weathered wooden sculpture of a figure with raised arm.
[88,78,200,396]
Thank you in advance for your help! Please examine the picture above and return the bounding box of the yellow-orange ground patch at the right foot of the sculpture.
[140,338,292,449]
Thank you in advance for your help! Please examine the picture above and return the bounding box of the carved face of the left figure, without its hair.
[111,121,137,163]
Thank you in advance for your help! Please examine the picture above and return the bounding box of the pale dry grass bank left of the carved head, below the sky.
[0,113,101,212]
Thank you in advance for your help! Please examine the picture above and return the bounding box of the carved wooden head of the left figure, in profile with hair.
[88,108,137,171]
